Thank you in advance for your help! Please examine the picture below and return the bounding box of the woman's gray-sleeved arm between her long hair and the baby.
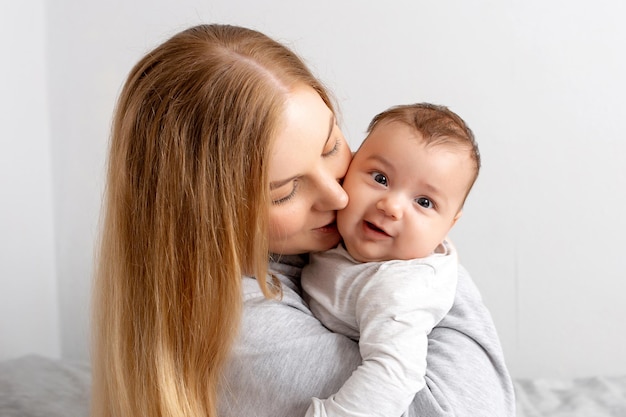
[220,276,361,417]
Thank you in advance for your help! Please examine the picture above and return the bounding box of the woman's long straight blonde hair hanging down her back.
[92,25,332,417]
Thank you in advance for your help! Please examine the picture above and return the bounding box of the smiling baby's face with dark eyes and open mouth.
[337,122,473,262]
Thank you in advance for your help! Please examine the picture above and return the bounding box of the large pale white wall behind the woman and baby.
[0,0,626,376]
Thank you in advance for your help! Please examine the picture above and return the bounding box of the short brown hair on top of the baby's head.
[367,103,481,204]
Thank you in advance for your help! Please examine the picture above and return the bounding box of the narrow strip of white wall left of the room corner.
[0,0,60,359]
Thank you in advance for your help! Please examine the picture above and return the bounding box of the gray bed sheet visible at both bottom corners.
[0,356,626,417]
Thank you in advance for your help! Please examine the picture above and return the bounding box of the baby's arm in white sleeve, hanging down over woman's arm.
[307,255,457,417]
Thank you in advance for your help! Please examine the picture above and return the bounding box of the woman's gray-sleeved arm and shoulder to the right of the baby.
[408,266,515,417]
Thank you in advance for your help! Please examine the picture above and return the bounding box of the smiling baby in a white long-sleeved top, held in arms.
[302,104,480,417]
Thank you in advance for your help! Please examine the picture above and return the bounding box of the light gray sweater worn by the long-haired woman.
[220,257,515,417]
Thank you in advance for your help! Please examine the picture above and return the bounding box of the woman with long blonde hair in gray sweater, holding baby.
[92,25,513,417]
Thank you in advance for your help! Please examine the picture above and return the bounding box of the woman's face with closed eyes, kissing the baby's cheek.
[269,86,352,255]
